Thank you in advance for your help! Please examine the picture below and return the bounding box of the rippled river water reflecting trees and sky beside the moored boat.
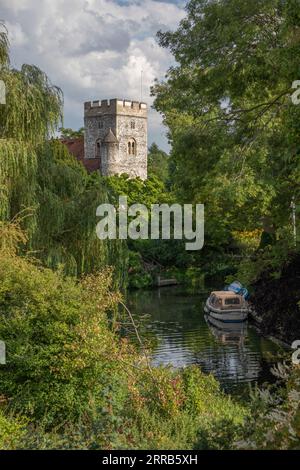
[127,286,283,396]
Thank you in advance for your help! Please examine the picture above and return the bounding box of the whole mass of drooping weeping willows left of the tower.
[0,23,127,283]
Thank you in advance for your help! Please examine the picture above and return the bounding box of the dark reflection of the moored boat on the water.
[204,315,247,345]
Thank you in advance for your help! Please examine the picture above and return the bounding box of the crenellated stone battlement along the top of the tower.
[84,98,147,115]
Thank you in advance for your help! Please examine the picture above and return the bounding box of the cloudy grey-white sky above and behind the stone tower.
[0,0,185,150]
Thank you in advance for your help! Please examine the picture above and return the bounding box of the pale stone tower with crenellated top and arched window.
[84,99,147,180]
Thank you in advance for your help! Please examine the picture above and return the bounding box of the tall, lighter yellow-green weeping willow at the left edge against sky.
[0,22,63,231]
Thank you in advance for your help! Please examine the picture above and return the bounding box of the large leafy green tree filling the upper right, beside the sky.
[152,0,300,264]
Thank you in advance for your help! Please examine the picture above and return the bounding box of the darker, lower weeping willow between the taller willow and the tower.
[31,140,127,284]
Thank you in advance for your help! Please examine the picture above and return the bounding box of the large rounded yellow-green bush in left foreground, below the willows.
[0,233,123,424]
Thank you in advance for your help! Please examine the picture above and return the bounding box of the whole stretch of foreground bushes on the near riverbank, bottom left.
[0,224,248,449]
